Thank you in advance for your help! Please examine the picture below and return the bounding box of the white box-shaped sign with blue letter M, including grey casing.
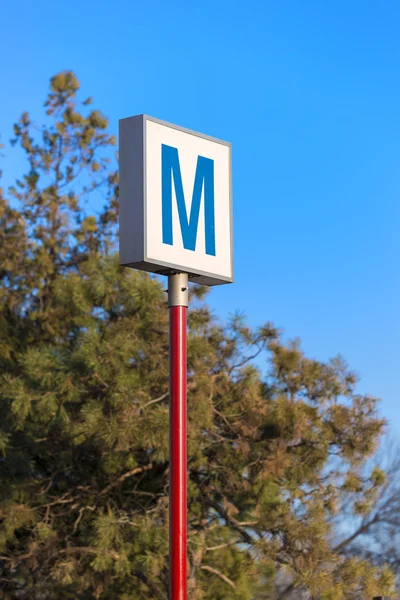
[119,115,233,285]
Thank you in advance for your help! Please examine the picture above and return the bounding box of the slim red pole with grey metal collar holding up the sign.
[168,273,189,600]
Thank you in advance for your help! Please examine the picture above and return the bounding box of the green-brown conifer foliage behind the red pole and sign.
[0,72,393,600]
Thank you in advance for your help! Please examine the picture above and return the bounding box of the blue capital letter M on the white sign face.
[161,144,215,256]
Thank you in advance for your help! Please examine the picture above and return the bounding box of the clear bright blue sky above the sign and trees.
[0,0,400,433]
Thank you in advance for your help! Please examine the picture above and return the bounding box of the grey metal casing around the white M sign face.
[119,114,234,286]
